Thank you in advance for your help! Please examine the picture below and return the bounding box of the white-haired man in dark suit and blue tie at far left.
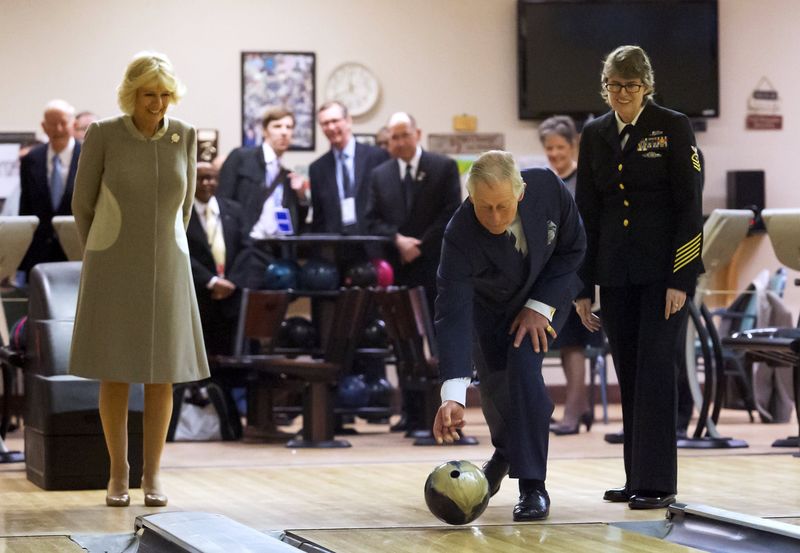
[19,100,81,273]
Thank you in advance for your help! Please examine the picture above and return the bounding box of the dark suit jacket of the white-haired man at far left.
[19,141,81,272]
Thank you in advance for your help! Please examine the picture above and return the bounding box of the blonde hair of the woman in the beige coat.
[117,52,186,115]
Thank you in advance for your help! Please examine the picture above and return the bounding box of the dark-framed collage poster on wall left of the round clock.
[242,52,316,151]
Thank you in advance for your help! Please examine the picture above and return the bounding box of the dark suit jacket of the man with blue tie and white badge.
[308,142,389,234]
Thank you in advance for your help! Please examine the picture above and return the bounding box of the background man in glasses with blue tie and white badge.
[308,102,389,234]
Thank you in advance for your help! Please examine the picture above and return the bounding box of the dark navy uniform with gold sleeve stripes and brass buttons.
[576,102,703,495]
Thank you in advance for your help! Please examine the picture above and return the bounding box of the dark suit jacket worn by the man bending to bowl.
[436,169,586,380]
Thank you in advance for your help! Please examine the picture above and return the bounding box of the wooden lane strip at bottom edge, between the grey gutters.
[290,524,699,553]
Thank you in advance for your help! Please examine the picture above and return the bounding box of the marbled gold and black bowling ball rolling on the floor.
[425,461,489,524]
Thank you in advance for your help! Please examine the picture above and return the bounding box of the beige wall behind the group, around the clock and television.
[0,0,800,314]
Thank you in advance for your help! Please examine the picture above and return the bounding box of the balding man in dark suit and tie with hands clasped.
[364,112,461,313]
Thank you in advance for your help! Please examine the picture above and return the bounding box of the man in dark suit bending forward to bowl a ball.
[433,151,586,521]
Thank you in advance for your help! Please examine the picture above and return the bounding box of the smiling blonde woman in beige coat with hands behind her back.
[70,52,209,506]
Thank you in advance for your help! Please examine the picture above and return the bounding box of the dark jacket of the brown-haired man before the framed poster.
[217,146,308,234]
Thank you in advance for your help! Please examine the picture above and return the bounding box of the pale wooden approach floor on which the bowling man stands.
[0,410,800,551]
